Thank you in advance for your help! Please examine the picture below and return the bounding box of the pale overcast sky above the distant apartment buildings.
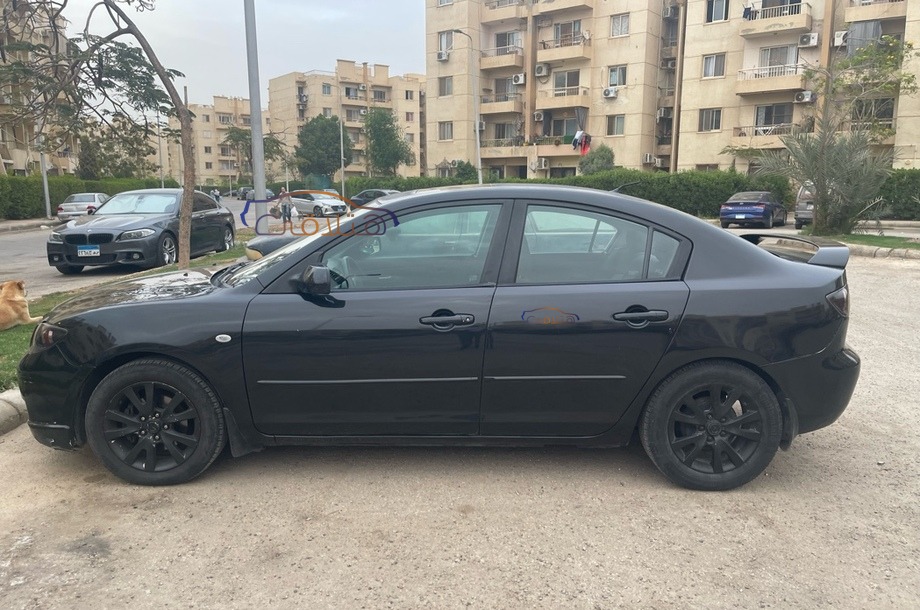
[65,0,425,107]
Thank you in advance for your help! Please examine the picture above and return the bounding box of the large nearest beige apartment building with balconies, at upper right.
[426,0,920,177]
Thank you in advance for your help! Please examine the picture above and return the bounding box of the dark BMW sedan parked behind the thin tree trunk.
[47,189,236,275]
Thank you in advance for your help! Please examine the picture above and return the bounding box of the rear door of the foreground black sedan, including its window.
[481,202,689,436]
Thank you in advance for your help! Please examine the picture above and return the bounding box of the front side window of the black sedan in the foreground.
[322,204,501,292]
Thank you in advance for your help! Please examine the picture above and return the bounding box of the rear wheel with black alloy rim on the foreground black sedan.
[639,361,783,491]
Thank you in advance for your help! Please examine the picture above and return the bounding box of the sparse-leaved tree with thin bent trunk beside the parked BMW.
[0,0,195,268]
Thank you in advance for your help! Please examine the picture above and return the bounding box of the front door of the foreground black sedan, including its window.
[243,201,511,436]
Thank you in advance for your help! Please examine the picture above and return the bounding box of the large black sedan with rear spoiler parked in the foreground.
[19,185,860,490]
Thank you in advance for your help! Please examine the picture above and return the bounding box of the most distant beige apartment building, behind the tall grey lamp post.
[162,95,275,187]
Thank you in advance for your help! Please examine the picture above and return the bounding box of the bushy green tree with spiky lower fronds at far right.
[754,36,917,235]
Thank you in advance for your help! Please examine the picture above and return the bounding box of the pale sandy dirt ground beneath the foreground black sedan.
[0,258,920,609]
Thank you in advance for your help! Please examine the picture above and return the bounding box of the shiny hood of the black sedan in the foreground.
[47,271,217,323]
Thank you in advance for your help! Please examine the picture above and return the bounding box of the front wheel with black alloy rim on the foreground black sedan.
[85,358,226,485]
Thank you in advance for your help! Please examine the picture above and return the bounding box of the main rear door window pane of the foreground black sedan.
[516,206,648,284]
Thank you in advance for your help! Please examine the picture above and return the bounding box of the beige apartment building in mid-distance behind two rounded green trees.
[268,59,426,178]
